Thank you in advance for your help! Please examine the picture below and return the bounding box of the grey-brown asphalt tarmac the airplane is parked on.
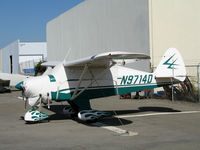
[0,92,200,150]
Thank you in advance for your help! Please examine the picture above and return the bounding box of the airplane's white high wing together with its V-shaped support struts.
[42,51,150,102]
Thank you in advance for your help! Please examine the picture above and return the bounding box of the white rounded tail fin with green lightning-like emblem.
[154,48,186,81]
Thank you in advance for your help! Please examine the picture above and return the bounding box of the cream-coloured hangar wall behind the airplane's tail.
[149,0,200,84]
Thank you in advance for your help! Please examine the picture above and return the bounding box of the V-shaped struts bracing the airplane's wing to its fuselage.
[71,61,115,100]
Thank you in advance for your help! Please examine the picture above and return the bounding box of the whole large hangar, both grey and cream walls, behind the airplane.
[47,0,200,82]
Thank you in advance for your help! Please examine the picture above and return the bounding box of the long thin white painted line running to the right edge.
[115,111,200,118]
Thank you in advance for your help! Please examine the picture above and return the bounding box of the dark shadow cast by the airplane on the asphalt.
[43,105,180,126]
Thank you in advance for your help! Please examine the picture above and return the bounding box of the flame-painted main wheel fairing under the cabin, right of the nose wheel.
[78,110,110,121]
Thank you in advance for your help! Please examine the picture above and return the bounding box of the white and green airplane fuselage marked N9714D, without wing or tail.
[23,65,157,105]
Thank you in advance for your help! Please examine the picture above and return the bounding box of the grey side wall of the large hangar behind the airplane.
[47,0,150,71]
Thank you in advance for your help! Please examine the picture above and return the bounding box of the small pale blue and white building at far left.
[1,40,47,74]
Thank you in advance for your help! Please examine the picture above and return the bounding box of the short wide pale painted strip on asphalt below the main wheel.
[92,122,138,136]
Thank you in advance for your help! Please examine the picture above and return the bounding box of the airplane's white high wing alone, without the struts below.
[42,51,150,67]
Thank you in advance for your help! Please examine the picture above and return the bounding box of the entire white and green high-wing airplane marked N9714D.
[16,48,186,122]
